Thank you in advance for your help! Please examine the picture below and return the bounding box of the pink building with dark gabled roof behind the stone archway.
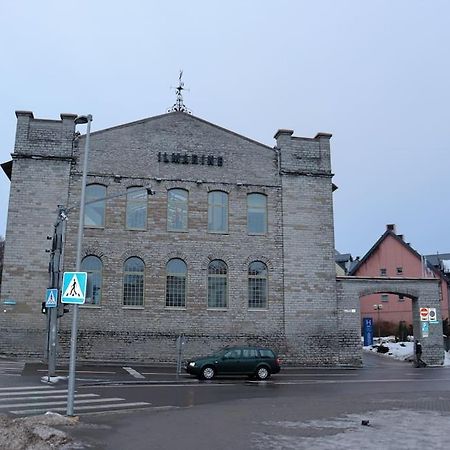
[350,225,449,335]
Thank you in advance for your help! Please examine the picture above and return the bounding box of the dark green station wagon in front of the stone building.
[185,347,280,380]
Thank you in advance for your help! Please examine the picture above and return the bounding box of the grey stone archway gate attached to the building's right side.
[336,277,444,366]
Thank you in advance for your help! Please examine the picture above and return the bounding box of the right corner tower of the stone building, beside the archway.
[274,130,339,365]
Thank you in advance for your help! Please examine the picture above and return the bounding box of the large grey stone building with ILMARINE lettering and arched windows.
[0,111,442,366]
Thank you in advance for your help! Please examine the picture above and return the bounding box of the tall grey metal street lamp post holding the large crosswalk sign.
[67,114,92,416]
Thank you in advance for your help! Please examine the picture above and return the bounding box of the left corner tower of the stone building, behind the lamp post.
[0,111,76,354]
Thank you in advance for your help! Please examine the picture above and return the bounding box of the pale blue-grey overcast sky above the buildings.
[0,0,450,257]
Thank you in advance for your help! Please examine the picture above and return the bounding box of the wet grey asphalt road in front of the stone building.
[0,354,450,450]
